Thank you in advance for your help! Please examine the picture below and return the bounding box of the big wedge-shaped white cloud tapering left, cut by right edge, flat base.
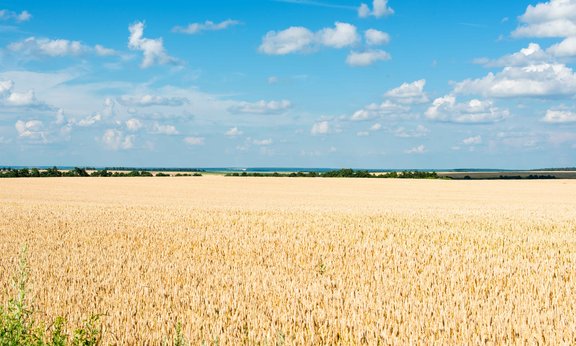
[454,64,576,98]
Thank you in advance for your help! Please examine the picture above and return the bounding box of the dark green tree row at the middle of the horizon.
[226,168,439,179]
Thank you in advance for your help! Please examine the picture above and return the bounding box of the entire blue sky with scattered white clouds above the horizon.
[0,0,576,169]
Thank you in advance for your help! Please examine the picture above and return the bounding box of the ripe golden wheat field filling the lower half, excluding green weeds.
[0,176,576,345]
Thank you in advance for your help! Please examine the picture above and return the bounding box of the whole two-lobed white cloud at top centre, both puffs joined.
[259,22,359,55]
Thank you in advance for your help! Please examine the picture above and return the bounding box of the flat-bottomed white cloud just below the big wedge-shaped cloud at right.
[426,95,510,123]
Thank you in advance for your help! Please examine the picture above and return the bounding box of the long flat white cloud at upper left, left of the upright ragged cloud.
[8,37,117,58]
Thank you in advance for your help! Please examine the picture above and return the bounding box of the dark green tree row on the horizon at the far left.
[0,167,202,178]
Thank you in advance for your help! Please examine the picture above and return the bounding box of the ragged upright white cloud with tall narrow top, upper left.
[128,22,181,68]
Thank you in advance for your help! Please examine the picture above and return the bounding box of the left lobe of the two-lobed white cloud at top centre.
[259,26,314,55]
